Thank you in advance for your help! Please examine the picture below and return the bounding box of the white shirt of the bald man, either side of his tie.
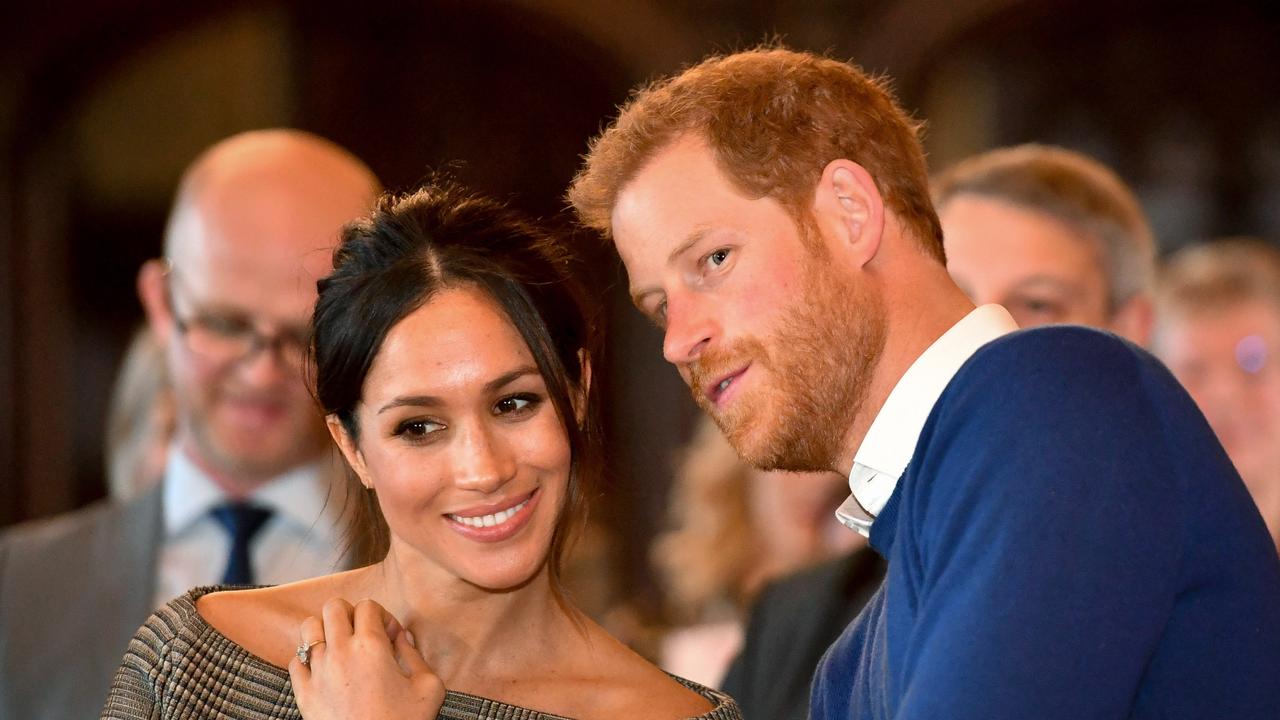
[155,445,344,607]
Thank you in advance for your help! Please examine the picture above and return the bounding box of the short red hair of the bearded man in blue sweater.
[568,47,943,260]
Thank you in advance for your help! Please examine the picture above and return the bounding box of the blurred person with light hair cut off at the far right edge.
[1153,238,1280,547]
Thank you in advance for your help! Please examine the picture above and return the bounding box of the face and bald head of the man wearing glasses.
[147,146,374,491]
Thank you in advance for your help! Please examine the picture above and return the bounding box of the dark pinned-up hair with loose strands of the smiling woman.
[311,179,602,589]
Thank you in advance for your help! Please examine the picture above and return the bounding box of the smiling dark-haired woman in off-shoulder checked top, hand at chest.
[102,183,740,720]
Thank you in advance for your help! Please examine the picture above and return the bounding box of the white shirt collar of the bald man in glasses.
[163,443,342,539]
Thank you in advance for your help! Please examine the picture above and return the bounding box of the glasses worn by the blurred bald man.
[165,260,311,366]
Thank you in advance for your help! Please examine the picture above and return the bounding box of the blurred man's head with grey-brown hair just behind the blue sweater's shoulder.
[933,145,1156,345]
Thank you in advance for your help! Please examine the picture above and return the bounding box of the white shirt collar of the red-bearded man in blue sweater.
[836,305,1018,536]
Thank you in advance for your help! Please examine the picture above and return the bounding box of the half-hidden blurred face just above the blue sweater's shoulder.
[938,193,1111,328]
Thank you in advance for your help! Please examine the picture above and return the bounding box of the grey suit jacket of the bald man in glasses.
[0,486,163,720]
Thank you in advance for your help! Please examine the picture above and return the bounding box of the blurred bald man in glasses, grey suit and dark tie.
[0,131,379,717]
